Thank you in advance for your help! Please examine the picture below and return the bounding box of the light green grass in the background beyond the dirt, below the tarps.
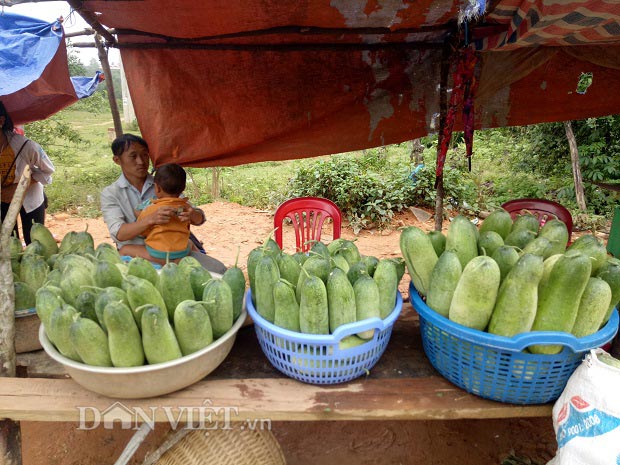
[44,107,422,217]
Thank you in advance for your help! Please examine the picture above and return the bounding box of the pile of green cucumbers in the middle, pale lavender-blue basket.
[248,239,405,345]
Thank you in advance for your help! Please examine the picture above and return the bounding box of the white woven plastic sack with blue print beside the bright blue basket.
[547,349,620,465]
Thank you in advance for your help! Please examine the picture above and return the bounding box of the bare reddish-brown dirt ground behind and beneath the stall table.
[22,202,556,465]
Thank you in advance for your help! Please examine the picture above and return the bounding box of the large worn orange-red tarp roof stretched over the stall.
[77,0,620,166]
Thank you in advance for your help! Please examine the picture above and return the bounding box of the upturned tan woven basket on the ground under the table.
[155,426,286,465]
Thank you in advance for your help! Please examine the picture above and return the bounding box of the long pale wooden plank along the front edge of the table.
[0,376,552,422]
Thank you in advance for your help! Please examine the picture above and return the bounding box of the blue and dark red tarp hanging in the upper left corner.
[0,13,101,124]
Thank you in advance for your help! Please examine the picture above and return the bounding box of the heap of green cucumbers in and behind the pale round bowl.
[14,225,245,367]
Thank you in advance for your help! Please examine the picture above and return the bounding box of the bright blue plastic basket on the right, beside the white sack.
[409,284,619,404]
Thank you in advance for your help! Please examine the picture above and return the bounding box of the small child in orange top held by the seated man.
[138,163,191,260]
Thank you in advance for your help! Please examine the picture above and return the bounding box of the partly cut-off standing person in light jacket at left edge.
[0,101,55,244]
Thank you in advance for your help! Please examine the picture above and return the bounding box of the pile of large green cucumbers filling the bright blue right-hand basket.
[400,209,620,354]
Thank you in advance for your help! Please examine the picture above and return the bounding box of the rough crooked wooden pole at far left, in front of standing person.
[0,166,31,465]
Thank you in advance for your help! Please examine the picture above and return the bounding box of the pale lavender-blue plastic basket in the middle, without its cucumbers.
[245,290,403,384]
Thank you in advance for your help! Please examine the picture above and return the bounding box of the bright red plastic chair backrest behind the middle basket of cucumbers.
[273,197,342,252]
